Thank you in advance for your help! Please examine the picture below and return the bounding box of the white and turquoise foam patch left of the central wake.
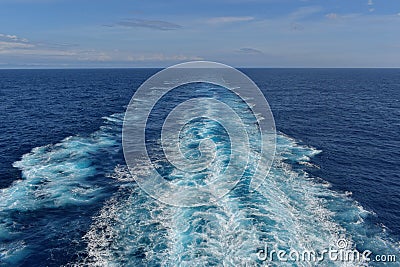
[0,115,122,264]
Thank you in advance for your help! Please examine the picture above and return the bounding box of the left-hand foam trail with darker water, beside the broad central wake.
[0,114,122,265]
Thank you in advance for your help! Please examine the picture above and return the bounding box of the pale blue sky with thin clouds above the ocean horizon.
[0,0,400,68]
